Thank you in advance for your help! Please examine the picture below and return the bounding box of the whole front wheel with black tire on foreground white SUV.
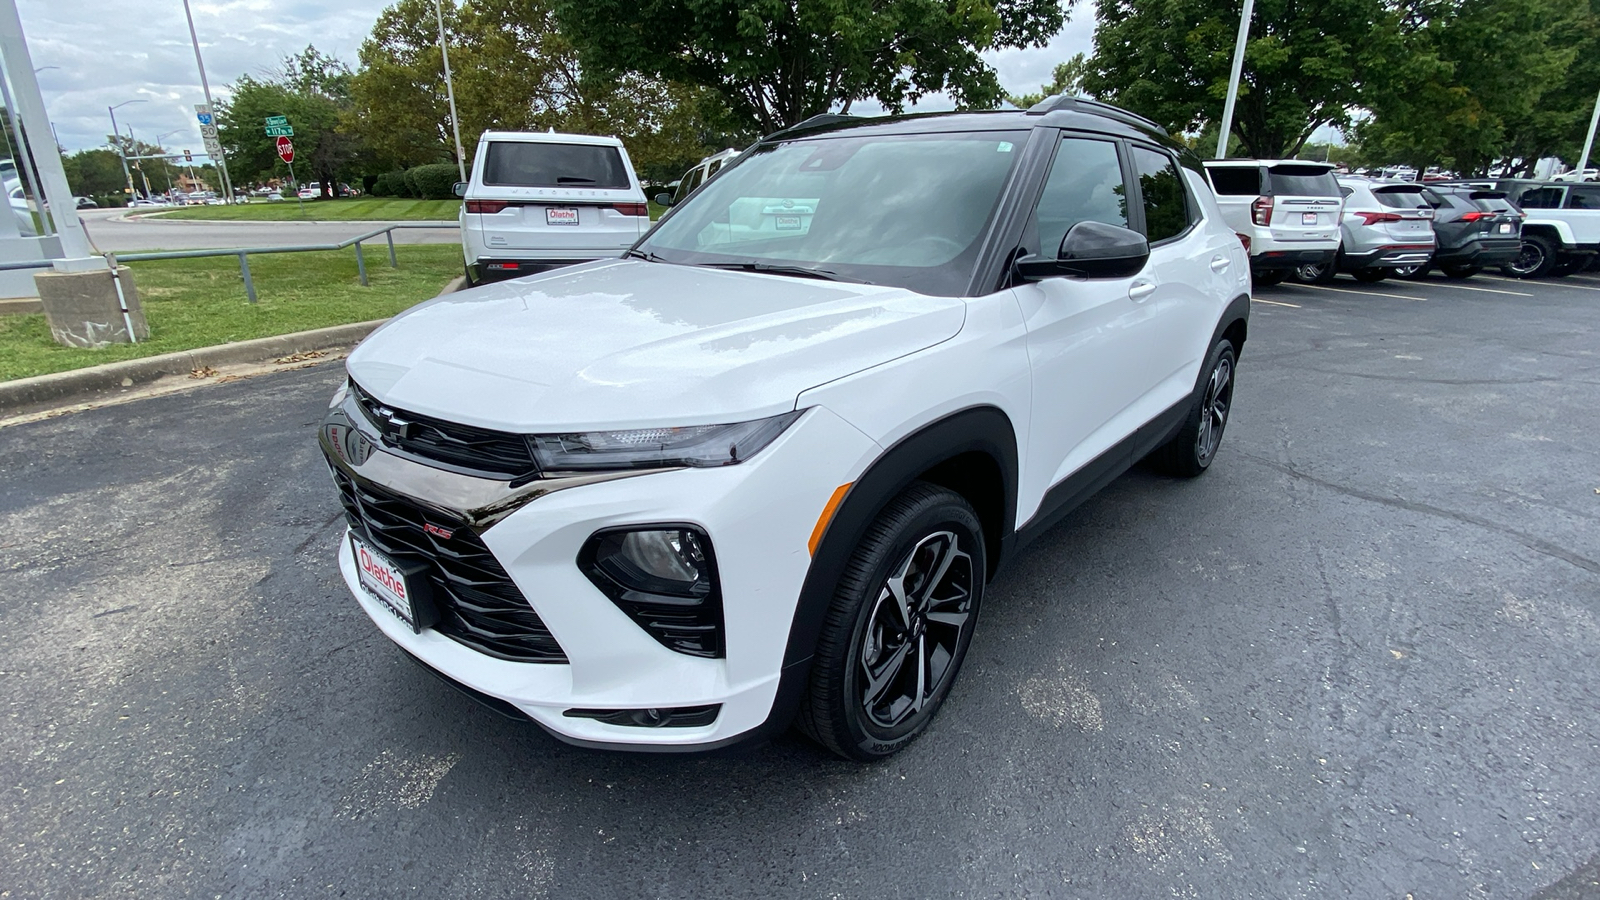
[795,482,987,762]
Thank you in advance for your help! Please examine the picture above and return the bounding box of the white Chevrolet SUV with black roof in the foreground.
[320,98,1250,759]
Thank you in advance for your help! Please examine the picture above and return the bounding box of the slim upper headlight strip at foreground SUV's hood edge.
[528,410,805,472]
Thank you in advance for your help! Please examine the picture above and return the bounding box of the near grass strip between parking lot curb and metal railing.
[0,243,461,381]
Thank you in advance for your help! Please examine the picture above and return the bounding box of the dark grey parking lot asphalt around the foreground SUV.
[9,269,1600,900]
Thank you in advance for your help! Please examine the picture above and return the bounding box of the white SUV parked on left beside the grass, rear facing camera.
[456,131,650,283]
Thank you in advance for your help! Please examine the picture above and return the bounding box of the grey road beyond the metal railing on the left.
[80,203,461,253]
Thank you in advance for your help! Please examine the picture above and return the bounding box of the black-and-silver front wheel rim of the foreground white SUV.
[861,532,974,729]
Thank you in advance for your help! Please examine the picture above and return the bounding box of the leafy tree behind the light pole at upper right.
[1083,0,1402,157]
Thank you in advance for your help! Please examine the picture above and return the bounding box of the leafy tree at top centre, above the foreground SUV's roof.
[554,0,1075,131]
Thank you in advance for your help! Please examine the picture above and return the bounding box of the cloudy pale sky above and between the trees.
[18,0,1094,151]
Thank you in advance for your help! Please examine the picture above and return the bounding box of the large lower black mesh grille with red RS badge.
[333,469,566,663]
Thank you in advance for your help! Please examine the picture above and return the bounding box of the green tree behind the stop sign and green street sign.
[218,46,362,197]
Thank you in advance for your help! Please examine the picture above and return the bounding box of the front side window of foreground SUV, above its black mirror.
[1035,138,1128,256]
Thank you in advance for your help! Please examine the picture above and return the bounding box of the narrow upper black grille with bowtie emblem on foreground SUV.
[350,381,538,477]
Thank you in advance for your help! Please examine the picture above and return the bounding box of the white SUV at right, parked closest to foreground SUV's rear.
[1205,160,1344,285]
